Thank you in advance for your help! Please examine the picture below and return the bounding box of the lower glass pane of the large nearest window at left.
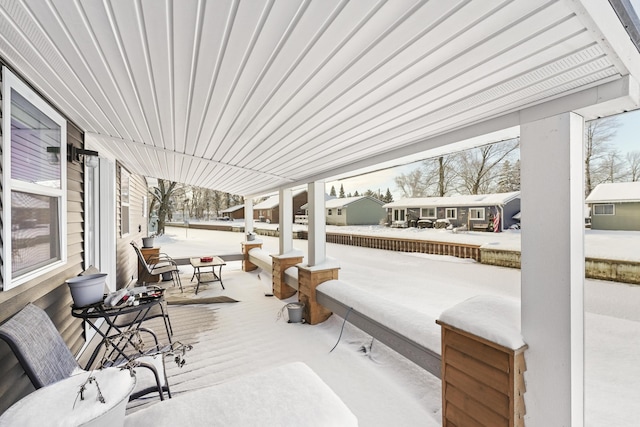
[11,191,60,277]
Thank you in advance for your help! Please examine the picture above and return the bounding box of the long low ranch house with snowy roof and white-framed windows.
[384,191,520,230]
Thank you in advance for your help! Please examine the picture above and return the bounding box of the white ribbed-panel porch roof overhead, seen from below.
[0,0,640,196]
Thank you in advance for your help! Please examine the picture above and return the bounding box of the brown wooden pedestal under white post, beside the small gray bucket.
[298,265,339,325]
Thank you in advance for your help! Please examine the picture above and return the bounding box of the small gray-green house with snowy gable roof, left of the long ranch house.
[302,196,385,225]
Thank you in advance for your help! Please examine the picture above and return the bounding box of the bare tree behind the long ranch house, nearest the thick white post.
[456,139,520,194]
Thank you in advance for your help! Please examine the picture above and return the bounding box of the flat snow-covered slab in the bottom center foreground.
[124,362,358,427]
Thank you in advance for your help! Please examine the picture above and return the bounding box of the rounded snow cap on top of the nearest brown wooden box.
[439,295,525,350]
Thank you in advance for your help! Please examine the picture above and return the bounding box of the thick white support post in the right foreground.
[520,113,585,426]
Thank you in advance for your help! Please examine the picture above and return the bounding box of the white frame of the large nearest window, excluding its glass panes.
[1,67,67,291]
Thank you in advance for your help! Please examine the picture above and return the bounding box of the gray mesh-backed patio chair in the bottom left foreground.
[0,303,171,400]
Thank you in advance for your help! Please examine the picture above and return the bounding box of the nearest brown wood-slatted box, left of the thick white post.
[436,320,526,427]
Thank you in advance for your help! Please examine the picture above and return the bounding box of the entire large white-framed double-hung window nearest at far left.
[2,68,67,290]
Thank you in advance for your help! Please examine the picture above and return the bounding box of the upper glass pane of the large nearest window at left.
[11,90,61,188]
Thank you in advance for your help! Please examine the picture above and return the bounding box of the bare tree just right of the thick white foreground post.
[584,117,622,196]
